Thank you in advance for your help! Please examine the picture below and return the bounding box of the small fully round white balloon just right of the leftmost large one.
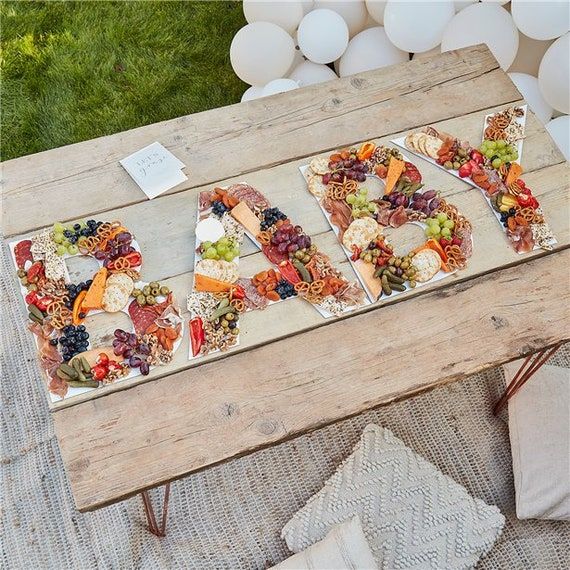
[297,9,348,63]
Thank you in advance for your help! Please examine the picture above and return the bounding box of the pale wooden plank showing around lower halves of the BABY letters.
[45,163,570,410]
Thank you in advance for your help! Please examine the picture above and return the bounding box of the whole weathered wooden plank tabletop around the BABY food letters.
[2,46,570,511]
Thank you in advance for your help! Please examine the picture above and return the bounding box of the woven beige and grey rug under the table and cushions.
[0,237,570,570]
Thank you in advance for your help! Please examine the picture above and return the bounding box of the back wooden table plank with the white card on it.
[2,46,520,235]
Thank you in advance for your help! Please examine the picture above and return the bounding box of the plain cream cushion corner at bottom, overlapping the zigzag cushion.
[273,517,378,570]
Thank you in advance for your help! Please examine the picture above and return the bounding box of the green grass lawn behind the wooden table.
[0,1,247,160]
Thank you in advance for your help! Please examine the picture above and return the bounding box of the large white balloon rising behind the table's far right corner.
[441,2,519,70]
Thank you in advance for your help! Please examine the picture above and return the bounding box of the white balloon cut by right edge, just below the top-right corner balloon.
[538,32,570,115]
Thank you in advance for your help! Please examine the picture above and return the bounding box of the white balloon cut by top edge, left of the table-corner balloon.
[384,0,455,53]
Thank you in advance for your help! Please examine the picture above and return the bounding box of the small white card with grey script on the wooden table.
[119,142,188,200]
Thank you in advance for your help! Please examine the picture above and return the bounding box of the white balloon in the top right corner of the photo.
[511,0,570,40]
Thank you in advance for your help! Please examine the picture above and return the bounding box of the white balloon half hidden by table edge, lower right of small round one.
[338,26,410,77]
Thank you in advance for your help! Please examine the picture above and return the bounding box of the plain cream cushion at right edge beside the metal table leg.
[504,361,570,520]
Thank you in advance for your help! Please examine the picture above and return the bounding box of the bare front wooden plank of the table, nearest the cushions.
[54,250,570,511]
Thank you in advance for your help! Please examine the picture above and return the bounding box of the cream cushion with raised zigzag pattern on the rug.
[281,424,505,570]
